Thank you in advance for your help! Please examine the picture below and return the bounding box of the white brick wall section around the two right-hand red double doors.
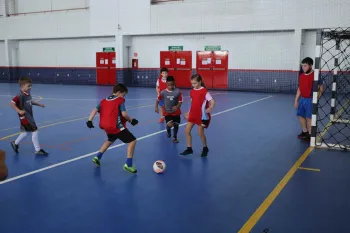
[132,32,296,70]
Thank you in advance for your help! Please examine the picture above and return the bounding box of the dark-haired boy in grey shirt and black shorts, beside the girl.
[155,76,182,143]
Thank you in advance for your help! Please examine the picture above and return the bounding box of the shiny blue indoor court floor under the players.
[0,84,350,233]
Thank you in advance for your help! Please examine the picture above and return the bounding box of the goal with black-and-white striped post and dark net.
[310,28,350,151]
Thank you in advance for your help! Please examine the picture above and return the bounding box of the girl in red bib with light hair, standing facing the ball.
[181,74,215,157]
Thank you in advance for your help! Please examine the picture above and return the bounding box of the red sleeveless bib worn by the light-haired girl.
[188,87,211,125]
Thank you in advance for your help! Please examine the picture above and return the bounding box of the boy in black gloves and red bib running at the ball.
[86,83,138,173]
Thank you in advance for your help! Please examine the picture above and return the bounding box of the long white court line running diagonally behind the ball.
[0,96,272,184]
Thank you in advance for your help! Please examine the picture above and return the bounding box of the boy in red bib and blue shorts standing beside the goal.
[294,57,323,142]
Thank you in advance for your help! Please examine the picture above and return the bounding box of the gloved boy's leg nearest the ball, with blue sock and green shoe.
[118,129,137,173]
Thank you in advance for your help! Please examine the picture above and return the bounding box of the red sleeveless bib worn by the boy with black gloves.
[100,96,126,134]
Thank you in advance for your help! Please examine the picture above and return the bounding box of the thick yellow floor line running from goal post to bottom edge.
[238,147,313,233]
